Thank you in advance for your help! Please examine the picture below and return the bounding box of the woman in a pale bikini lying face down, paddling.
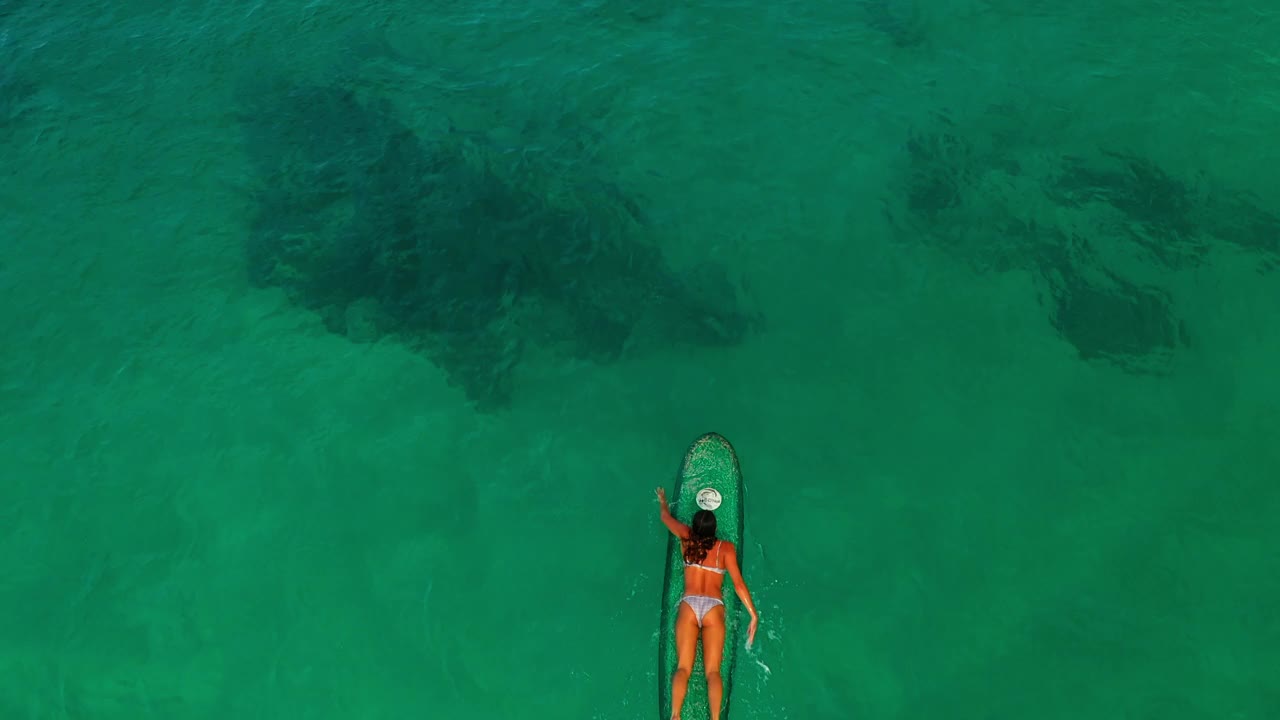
[658,488,760,720]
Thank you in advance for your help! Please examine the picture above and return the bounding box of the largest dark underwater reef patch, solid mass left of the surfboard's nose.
[241,82,760,410]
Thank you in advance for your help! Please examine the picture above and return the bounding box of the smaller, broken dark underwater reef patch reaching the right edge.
[890,120,1280,374]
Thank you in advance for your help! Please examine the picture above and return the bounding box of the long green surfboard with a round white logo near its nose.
[658,433,746,720]
